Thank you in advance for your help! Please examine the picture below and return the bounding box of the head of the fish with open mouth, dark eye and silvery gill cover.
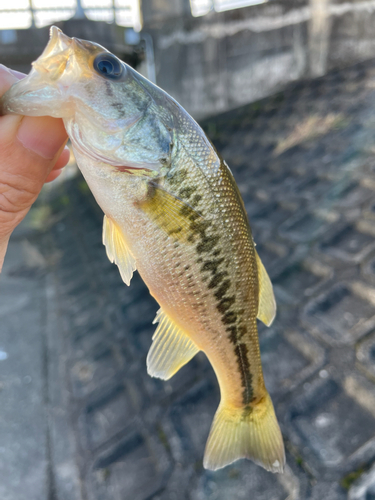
[0,26,172,174]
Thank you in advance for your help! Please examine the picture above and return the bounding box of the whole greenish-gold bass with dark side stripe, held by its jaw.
[0,27,285,473]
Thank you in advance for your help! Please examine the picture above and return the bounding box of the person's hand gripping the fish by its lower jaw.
[0,64,70,272]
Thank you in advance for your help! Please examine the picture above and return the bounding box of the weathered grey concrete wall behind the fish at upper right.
[142,0,375,118]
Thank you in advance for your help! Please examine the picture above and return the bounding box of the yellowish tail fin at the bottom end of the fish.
[203,393,285,472]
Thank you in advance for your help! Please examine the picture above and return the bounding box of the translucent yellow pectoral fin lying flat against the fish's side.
[139,181,203,241]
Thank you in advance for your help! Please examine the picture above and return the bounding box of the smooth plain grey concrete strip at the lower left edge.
[0,254,49,500]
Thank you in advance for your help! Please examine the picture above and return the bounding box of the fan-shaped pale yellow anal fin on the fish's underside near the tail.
[147,309,199,380]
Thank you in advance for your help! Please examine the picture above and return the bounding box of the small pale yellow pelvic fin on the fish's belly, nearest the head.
[103,215,136,285]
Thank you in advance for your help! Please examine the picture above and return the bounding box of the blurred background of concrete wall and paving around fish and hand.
[0,0,375,500]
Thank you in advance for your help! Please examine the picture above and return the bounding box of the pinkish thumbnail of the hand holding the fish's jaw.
[17,116,67,160]
